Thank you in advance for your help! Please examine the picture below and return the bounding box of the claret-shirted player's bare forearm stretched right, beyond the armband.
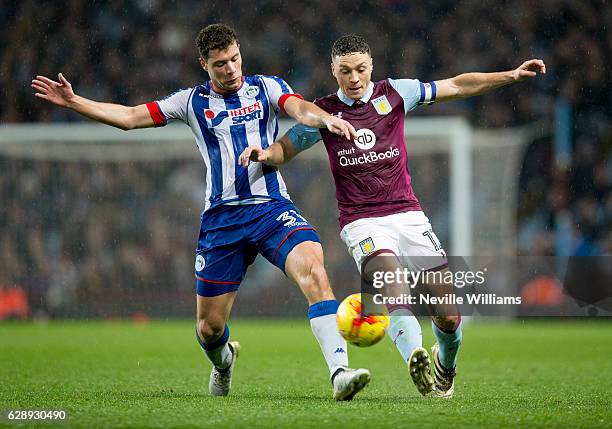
[436,59,546,102]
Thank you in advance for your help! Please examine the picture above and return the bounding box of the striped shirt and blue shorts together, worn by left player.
[147,75,320,296]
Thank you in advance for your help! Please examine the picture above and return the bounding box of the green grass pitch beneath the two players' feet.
[0,320,612,429]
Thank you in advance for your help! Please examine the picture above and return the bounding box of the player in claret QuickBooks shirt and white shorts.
[240,34,546,397]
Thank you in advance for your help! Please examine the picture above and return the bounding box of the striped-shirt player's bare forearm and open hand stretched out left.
[32,73,154,130]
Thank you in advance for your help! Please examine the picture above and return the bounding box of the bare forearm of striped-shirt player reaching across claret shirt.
[284,97,357,140]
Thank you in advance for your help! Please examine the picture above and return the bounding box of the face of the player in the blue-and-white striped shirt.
[200,43,242,92]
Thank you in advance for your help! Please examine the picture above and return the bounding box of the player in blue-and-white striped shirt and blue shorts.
[32,24,370,400]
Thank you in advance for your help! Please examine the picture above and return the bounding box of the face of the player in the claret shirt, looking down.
[332,52,372,100]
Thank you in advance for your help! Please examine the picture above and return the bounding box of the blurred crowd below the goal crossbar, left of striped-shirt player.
[0,157,198,316]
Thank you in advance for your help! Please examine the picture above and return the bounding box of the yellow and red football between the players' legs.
[336,293,389,347]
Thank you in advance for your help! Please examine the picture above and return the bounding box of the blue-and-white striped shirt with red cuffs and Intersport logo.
[147,75,300,211]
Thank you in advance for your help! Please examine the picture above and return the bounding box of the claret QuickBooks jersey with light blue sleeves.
[287,79,436,227]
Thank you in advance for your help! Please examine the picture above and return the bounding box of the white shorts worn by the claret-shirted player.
[340,211,448,272]
